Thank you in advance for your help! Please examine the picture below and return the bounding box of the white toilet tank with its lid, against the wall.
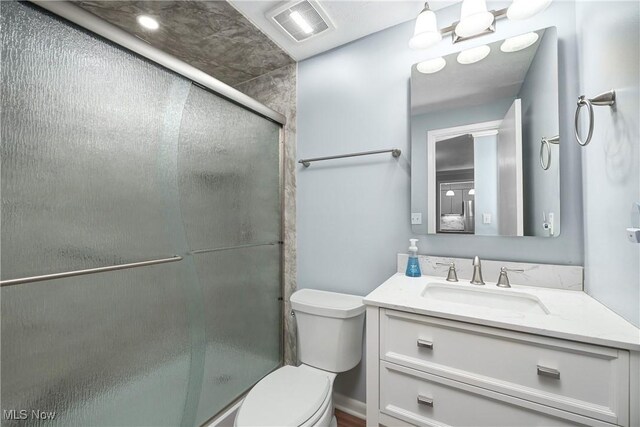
[291,289,365,372]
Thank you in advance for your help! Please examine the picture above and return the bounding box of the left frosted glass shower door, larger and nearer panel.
[0,2,196,426]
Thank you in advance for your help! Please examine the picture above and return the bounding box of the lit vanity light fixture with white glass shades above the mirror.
[409,0,553,52]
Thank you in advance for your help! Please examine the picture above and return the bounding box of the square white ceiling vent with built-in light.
[267,0,335,42]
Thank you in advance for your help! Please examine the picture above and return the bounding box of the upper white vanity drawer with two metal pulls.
[380,310,629,425]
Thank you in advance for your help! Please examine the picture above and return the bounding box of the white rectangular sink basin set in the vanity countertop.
[421,283,549,314]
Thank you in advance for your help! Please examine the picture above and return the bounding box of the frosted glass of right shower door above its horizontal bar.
[178,86,280,249]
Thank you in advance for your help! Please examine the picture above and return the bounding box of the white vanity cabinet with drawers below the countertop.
[366,306,630,427]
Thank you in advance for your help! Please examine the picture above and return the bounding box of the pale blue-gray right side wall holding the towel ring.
[576,1,640,326]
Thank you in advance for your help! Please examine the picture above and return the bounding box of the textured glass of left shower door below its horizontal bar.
[0,262,191,426]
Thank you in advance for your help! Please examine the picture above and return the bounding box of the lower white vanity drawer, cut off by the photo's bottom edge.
[380,362,612,427]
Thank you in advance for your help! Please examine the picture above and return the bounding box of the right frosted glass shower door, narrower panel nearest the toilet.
[178,86,282,424]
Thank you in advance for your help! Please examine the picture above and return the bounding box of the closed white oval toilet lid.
[236,366,330,426]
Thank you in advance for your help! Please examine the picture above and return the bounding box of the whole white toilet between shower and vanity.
[234,289,365,427]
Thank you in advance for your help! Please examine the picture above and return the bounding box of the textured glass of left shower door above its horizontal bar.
[0,2,191,279]
